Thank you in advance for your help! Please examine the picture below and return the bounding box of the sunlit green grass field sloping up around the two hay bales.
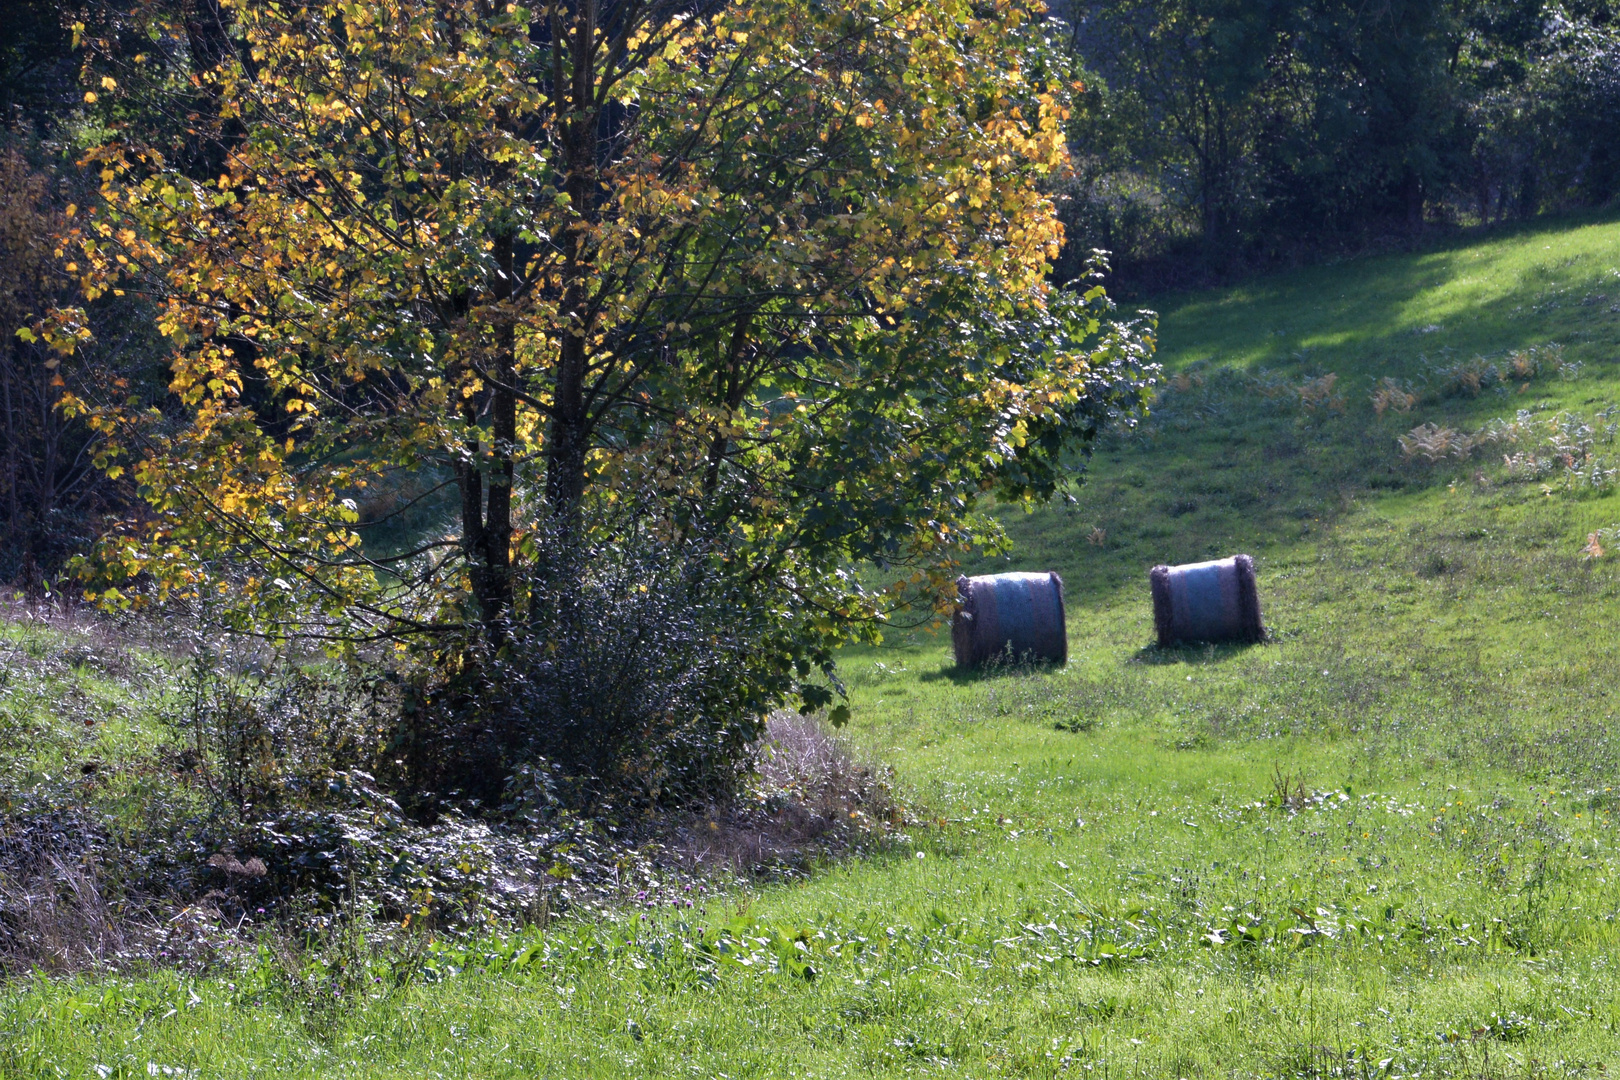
[0,208,1620,1078]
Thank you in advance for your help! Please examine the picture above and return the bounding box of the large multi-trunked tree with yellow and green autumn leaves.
[49,0,1152,718]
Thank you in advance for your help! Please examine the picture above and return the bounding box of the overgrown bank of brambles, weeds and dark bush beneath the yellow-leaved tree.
[0,592,899,975]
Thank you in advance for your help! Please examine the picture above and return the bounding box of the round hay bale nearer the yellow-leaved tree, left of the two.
[951,572,1069,667]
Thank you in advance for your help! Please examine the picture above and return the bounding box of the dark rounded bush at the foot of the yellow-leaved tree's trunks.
[392,513,816,816]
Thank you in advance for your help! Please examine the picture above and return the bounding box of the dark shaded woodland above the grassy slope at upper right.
[1059,0,1620,288]
